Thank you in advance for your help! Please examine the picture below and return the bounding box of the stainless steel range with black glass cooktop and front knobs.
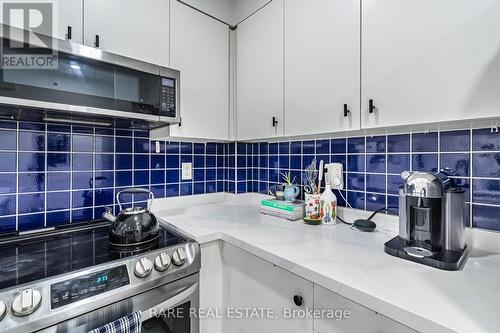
[0,222,200,333]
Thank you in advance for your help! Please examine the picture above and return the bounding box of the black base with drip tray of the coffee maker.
[384,236,468,271]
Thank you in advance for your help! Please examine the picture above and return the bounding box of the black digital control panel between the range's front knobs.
[50,265,130,310]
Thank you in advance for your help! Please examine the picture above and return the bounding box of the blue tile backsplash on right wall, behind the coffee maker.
[235,128,500,231]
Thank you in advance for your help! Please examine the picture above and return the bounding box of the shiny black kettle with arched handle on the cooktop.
[102,188,159,246]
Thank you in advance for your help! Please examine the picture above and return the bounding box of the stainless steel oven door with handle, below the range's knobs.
[41,273,199,333]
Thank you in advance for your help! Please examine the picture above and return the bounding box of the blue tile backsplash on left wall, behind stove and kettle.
[0,121,227,233]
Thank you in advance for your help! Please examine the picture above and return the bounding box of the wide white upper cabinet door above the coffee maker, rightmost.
[361,0,500,128]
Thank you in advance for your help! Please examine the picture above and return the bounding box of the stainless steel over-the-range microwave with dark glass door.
[0,25,180,127]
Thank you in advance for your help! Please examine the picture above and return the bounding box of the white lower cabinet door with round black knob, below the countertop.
[222,243,313,333]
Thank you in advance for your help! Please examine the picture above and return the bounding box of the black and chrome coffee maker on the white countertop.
[385,171,468,270]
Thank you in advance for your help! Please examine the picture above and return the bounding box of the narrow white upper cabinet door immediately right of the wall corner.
[236,0,283,139]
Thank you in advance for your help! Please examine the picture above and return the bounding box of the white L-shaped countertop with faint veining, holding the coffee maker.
[153,194,500,333]
